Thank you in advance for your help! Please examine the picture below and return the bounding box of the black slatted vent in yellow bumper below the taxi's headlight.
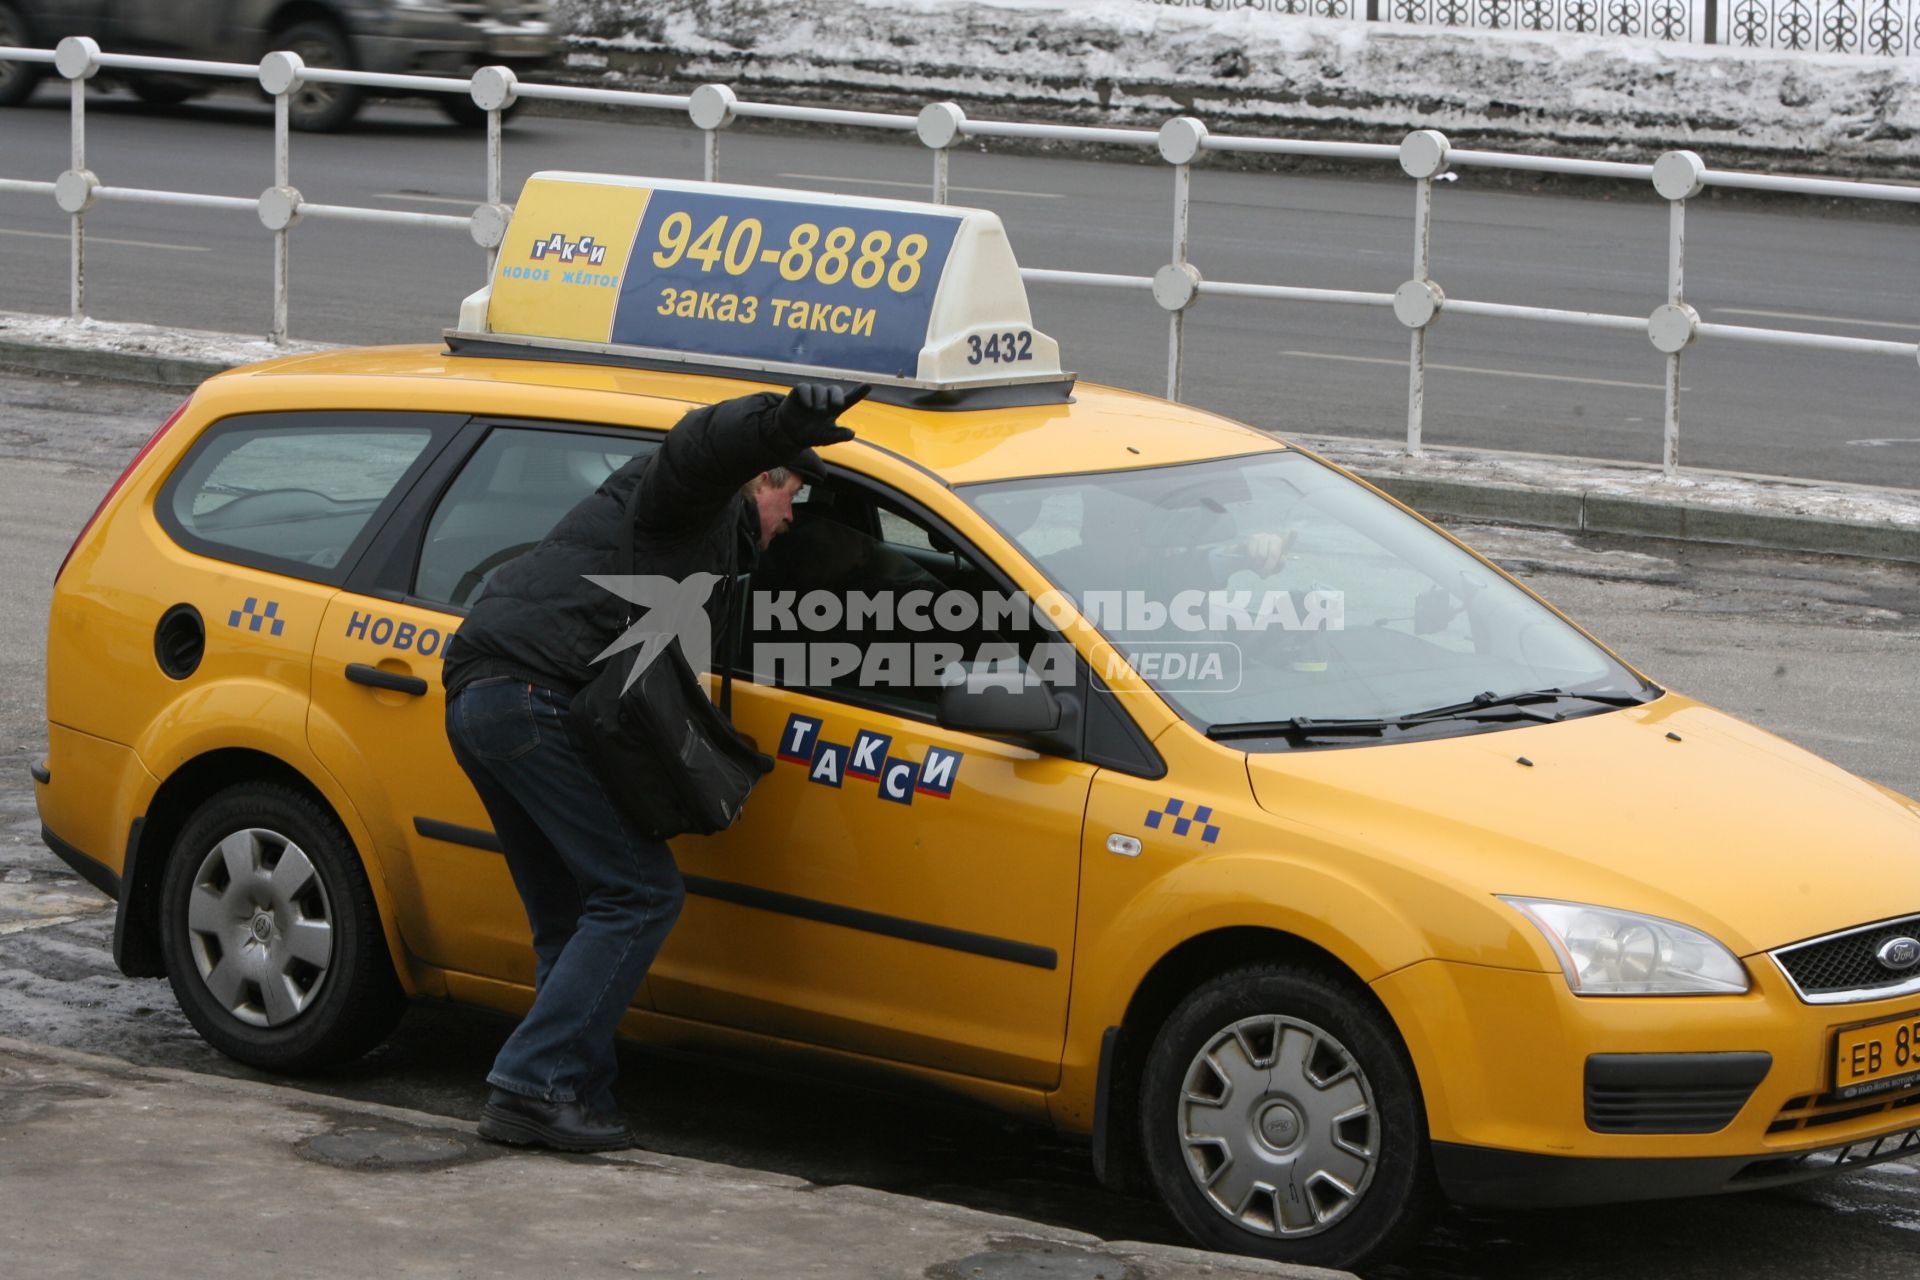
[1586,1054,1772,1134]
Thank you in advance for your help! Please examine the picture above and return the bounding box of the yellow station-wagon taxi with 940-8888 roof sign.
[35,175,1920,1265]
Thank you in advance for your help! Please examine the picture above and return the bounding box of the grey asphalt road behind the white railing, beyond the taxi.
[0,86,1920,487]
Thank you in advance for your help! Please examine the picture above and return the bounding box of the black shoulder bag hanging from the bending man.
[568,486,774,841]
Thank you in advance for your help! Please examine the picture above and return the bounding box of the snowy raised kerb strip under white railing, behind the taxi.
[0,311,1920,562]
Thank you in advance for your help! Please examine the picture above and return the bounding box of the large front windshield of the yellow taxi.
[960,451,1651,729]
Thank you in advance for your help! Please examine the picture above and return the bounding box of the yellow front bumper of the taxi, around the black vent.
[1373,960,1920,1205]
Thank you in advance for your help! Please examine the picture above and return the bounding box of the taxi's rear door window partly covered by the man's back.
[413,426,657,608]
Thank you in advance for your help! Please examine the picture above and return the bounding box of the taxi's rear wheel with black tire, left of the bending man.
[159,783,405,1073]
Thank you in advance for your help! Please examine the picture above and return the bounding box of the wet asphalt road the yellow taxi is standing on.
[0,364,1920,1280]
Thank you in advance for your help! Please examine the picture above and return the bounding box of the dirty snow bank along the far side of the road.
[559,0,1920,173]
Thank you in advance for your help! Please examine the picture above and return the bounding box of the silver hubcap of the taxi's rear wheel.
[186,827,334,1027]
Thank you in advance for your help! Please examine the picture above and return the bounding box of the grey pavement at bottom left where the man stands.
[0,1038,1346,1280]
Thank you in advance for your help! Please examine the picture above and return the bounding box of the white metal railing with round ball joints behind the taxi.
[0,36,1920,476]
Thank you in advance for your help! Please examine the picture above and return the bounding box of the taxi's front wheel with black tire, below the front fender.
[1140,963,1438,1268]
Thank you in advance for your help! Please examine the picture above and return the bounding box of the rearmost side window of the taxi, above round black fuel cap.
[157,413,463,581]
